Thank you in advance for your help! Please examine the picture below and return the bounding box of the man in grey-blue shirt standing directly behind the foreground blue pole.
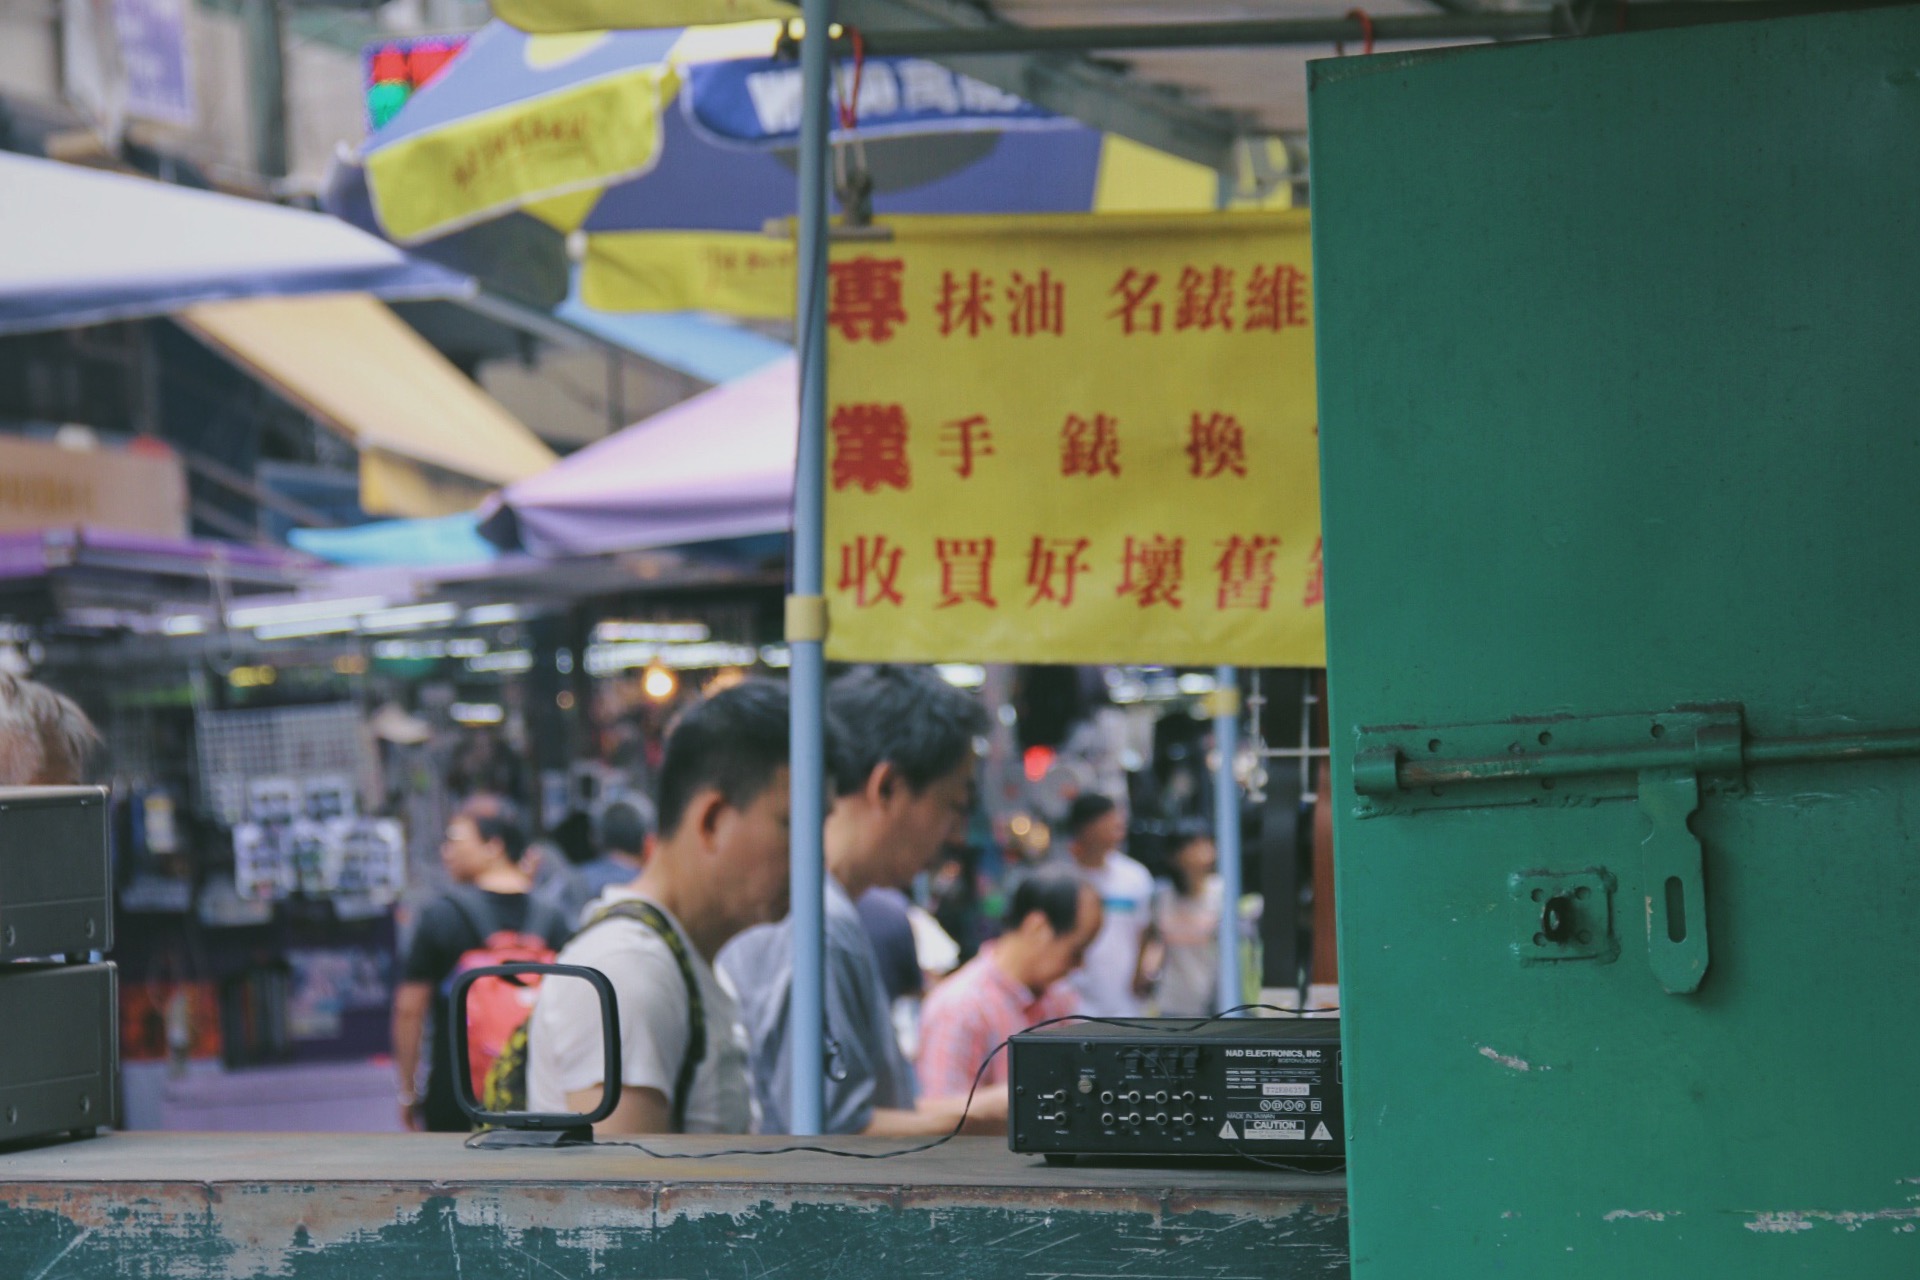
[720,666,1006,1136]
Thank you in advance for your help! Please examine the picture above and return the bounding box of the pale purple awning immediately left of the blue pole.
[480,359,799,557]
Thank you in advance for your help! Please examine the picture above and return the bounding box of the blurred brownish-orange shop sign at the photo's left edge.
[0,436,186,537]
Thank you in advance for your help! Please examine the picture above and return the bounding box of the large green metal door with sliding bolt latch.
[1311,8,1920,1280]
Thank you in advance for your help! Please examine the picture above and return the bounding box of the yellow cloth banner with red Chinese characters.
[826,213,1327,666]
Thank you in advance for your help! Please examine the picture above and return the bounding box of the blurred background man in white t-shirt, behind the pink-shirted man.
[1064,793,1154,1017]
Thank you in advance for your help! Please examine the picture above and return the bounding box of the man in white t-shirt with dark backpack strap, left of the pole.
[526,681,791,1134]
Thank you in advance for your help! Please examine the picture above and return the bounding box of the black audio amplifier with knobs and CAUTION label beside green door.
[1006,1017,1346,1161]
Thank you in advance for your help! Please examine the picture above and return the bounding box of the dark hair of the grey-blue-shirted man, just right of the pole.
[828,666,987,796]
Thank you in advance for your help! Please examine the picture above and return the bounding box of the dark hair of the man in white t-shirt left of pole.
[660,679,787,835]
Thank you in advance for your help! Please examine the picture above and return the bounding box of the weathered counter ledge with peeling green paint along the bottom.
[0,1132,1348,1280]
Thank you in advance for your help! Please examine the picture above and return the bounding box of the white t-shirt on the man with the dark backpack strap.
[526,889,753,1134]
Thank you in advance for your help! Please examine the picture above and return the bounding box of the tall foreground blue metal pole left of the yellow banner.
[787,0,833,1134]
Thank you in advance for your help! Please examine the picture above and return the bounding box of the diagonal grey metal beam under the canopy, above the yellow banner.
[837,0,1250,173]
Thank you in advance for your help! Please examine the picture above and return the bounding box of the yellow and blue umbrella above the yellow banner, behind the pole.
[349,23,1274,319]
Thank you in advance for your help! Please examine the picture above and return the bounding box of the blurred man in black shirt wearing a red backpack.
[394,794,568,1132]
